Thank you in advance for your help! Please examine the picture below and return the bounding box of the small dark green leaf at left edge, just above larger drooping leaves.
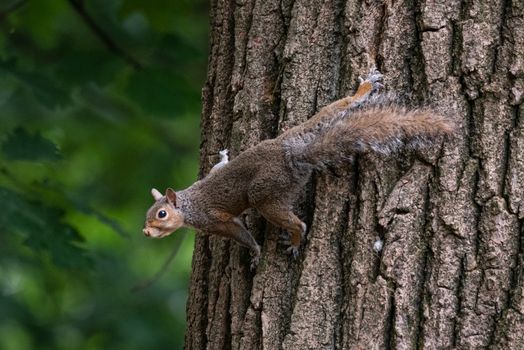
[2,127,61,161]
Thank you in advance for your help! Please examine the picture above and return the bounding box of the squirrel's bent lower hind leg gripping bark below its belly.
[257,203,306,258]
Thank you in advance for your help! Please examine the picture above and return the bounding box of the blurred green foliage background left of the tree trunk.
[0,0,209,350]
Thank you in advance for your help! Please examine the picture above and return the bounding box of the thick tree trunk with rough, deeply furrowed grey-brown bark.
[186,0,524,349]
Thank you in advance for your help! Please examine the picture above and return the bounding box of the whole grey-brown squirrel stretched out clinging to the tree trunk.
[143,69,454,267]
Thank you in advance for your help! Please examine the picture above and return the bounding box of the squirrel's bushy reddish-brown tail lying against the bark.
[302,105,455,166]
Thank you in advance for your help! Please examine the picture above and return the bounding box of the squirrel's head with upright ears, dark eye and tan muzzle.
[142,188,184,238]
